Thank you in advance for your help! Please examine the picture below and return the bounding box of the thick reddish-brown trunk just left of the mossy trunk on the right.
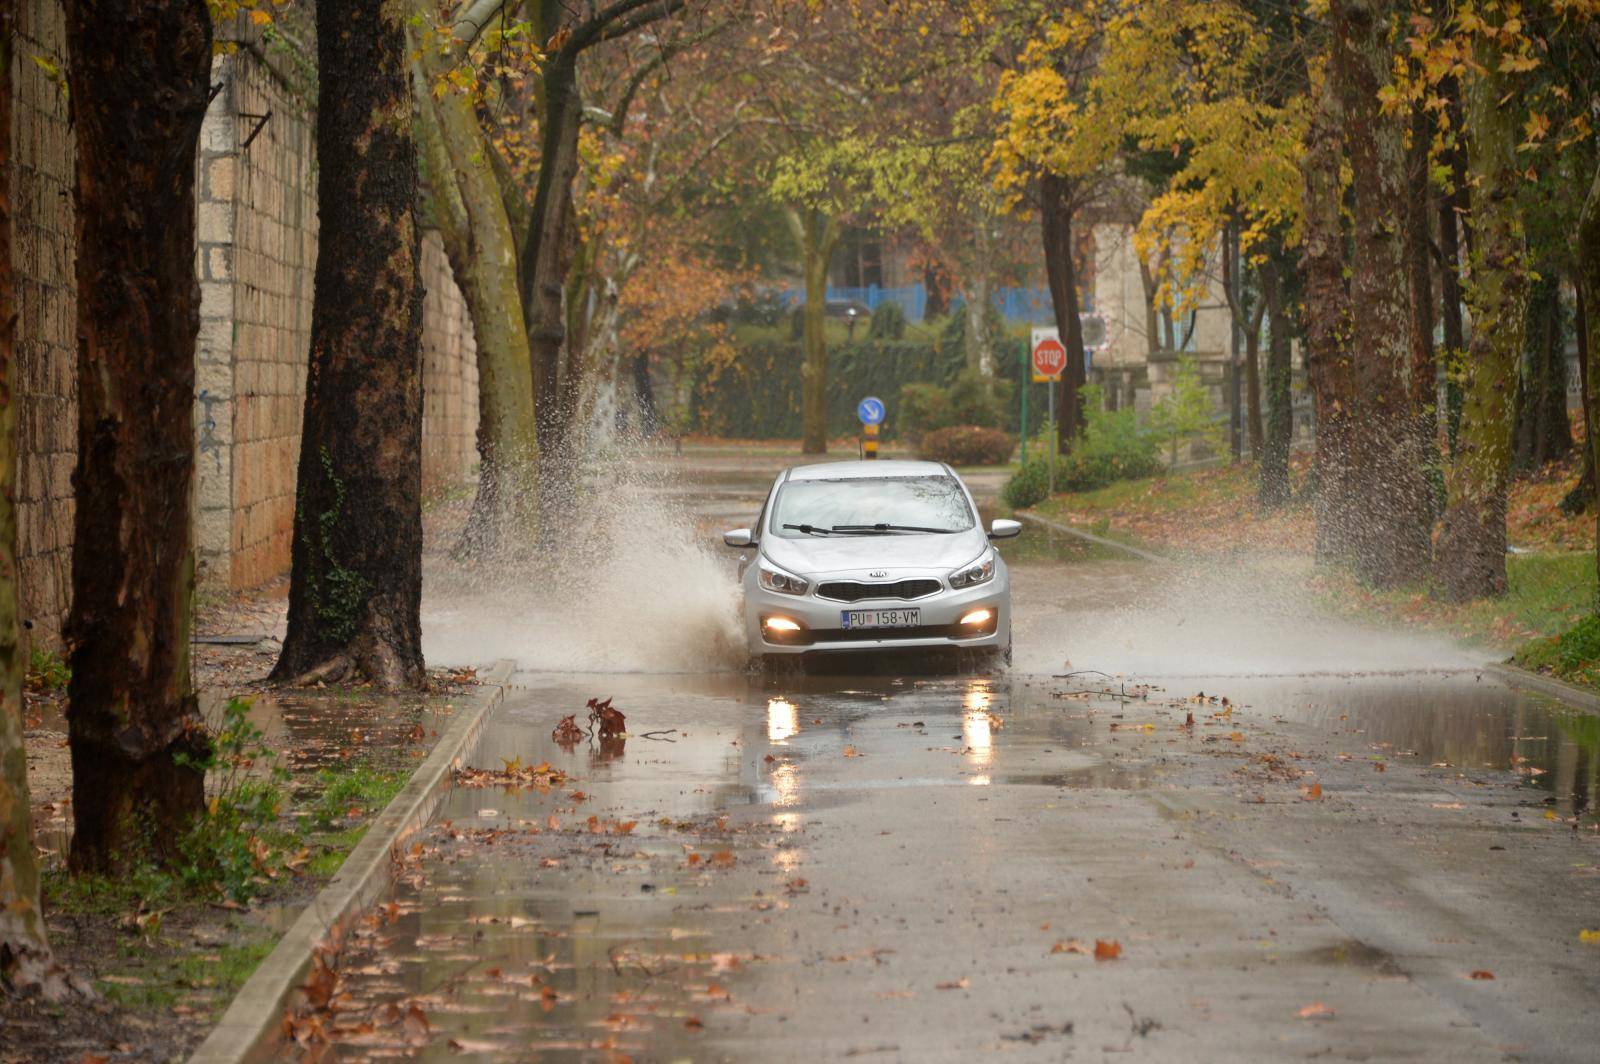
[1330,0,1434,587]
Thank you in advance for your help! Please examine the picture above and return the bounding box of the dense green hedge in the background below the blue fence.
[690,339,1045,440]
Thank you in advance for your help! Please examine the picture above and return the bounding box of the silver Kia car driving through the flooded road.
[722,461,1022,661]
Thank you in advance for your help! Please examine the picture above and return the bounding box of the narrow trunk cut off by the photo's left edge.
[0,0,66,1000]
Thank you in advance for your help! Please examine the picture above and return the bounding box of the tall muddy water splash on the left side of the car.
[422,448,744,672]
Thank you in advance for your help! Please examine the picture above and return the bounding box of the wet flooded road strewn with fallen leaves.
[324,451,1600,1061]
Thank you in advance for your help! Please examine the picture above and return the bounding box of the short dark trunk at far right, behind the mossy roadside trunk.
[1512,267,1573,469]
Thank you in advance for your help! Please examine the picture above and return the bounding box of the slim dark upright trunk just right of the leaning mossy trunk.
[522,48,582,531]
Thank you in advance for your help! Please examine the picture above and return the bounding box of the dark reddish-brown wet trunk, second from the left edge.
[67,0,211,872]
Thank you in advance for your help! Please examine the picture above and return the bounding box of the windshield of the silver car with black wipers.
[771,477,973,539]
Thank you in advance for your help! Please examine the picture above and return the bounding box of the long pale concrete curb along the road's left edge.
[189,661,515,1064]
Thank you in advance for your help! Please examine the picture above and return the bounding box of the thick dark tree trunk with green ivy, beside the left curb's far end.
[272,0,427,690]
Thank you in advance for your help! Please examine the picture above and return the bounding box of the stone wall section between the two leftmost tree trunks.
[11,0,78,645]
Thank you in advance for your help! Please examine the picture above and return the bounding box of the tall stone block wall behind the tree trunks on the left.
[11,0,477,646]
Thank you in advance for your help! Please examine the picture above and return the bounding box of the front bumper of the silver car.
[744,571,1011,654]
